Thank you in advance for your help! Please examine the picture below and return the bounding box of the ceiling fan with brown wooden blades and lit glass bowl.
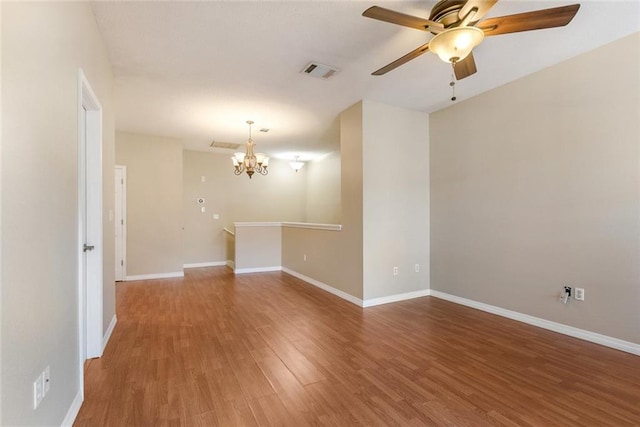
[362,0,580,80]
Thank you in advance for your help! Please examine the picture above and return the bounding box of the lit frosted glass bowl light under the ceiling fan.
[429,27,484,63]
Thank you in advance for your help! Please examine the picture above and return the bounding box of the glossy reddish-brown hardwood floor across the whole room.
[75,267,640,427]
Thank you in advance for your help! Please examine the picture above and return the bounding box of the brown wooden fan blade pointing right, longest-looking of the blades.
[477,4,580,36]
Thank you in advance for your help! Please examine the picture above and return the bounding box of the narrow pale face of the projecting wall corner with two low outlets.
[362,101,429,300]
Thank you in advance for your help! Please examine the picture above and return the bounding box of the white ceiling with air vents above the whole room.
[93,0,640,160]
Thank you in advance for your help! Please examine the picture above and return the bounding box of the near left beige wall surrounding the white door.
[0,2,114,426]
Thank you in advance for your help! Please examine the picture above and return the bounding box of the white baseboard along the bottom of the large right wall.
[431,290,640,356]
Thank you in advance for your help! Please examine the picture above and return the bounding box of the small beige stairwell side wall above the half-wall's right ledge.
[303,151,341,224]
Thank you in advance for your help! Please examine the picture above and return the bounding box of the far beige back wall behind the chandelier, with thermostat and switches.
[182,151,306,265]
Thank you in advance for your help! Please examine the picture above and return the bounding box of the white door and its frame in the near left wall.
[78,69,103,396]
